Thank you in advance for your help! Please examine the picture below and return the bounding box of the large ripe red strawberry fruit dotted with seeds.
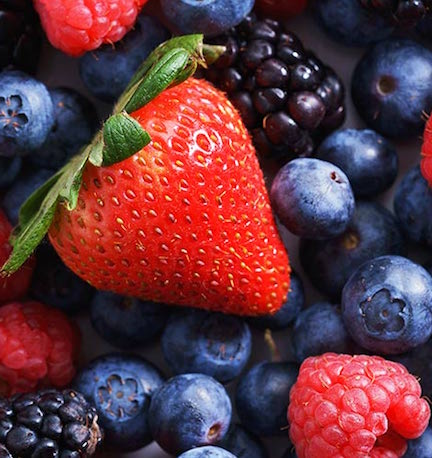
[2,36,289,315]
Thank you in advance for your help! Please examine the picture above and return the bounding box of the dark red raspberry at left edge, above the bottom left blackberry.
[0,302,80,396]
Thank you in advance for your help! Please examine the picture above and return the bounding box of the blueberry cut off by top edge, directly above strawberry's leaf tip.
[161,0,255,37]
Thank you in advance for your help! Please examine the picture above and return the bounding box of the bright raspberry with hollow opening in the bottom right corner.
[288,353,430,458]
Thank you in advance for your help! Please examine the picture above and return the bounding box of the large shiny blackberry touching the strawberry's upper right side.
[205,15,345,160]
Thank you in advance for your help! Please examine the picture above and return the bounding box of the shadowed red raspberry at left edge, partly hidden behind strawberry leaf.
[0,210,35,304]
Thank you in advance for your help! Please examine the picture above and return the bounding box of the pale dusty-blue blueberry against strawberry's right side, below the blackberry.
[270,158,354,239]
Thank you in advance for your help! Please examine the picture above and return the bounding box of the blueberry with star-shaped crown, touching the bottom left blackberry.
[74,353,164,452]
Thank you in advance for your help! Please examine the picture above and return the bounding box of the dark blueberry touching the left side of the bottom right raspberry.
[235,362,298,436]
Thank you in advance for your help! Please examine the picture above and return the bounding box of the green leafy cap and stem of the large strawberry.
[1,35,224,275]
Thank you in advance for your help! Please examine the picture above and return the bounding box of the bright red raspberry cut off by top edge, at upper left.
[34,0,147,56]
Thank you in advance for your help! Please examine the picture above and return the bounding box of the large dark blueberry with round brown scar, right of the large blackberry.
[352,39,432,138]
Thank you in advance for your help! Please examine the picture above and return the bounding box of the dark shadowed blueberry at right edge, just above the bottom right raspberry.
[392,339,432,400]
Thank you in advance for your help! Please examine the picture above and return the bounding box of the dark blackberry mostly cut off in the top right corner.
[359,0,432,28]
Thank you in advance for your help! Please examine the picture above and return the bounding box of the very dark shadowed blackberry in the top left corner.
[0,0,42,73]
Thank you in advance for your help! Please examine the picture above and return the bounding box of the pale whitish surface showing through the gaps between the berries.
[39,0,428,458]
